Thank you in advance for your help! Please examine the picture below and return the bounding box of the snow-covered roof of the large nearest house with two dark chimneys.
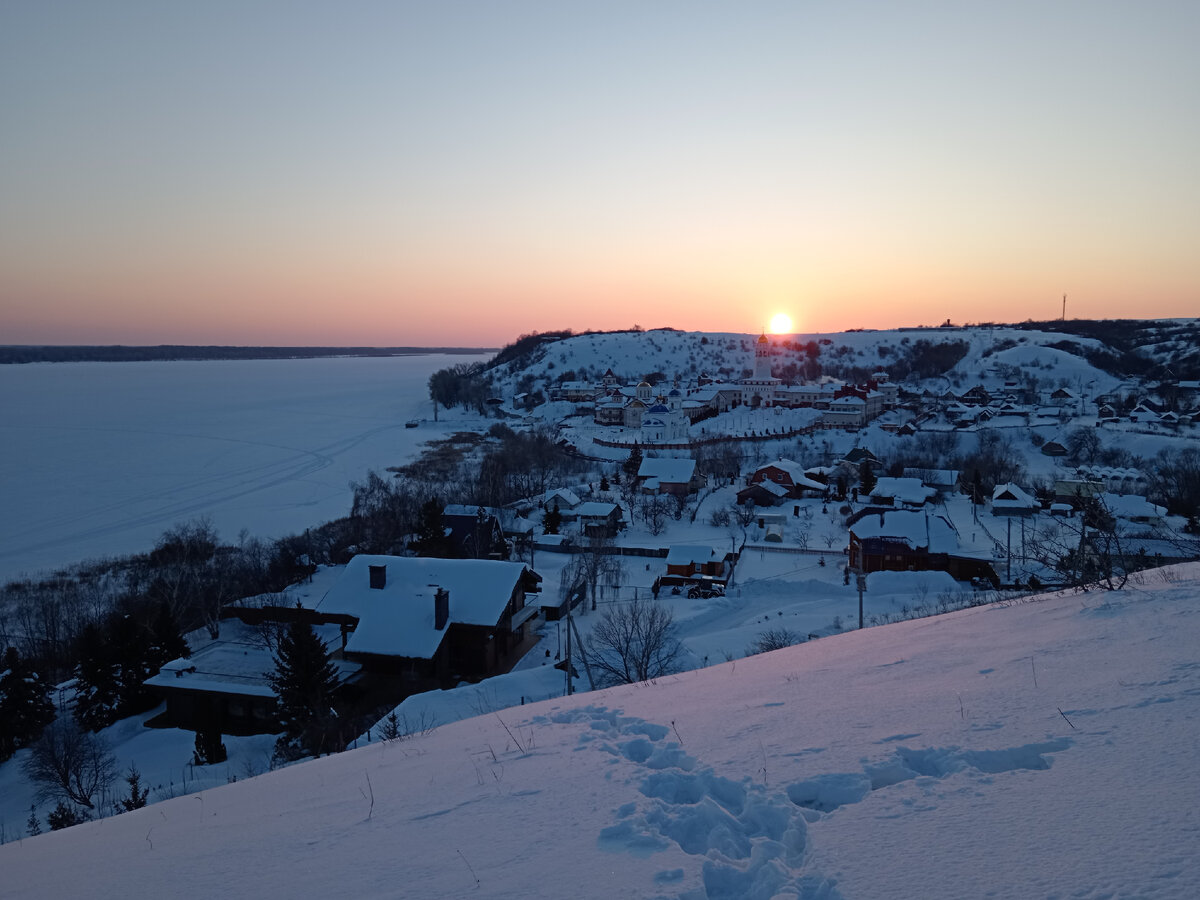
[317,554,526,659]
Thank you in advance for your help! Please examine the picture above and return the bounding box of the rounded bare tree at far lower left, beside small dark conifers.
[24,719,116,810]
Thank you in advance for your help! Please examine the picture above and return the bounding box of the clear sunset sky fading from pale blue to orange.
[0,0,1200,346]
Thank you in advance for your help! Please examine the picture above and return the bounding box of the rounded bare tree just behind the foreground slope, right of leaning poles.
[588,598,685,686]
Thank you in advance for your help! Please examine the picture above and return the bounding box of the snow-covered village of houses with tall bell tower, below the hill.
[124,324,1198,768]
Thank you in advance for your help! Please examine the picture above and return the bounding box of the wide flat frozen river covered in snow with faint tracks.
[0,354,490,581]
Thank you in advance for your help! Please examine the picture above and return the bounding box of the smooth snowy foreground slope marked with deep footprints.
[9,564,1200,900]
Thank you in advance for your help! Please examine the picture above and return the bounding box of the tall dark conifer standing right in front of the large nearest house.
[268,622,337,760]
